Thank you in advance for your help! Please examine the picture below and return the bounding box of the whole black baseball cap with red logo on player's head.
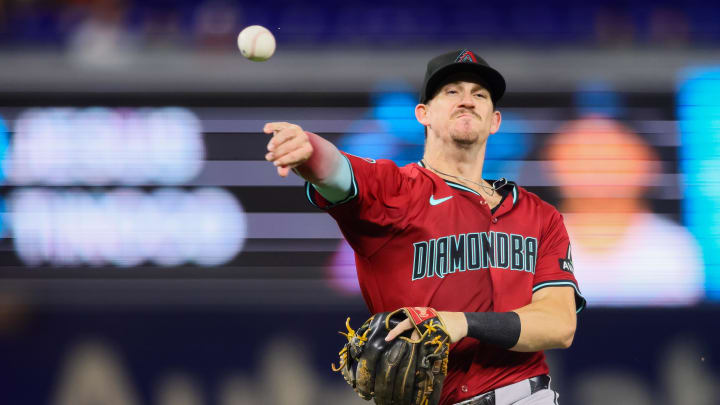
[420,49,505,105]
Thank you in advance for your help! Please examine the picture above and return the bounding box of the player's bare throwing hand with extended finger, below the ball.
[263,122,313,177]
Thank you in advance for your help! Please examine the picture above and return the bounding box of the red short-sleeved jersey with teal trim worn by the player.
[306,153,585,404]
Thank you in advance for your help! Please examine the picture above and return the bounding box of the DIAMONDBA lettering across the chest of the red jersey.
[412,231,538,281]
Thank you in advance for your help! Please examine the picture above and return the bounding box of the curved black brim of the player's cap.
[420,63,505,104]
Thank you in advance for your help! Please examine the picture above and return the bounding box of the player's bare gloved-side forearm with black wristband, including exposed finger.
[386,287,576,352]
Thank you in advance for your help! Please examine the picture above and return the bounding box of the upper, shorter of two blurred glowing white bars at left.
[7,107,205,185]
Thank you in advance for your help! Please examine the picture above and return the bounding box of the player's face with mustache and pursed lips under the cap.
[416,79,500,145]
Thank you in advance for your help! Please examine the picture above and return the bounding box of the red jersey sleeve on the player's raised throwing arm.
[305,152,411,257]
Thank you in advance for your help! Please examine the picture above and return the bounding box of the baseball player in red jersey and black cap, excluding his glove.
[264,50,585,405]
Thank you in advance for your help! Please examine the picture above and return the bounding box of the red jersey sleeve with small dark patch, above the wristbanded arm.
[533,208,586,312]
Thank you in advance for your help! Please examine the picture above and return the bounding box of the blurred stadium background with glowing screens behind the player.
[0,0,720,405]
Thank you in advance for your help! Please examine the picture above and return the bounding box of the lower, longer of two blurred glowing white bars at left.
[9,188,247,267]
